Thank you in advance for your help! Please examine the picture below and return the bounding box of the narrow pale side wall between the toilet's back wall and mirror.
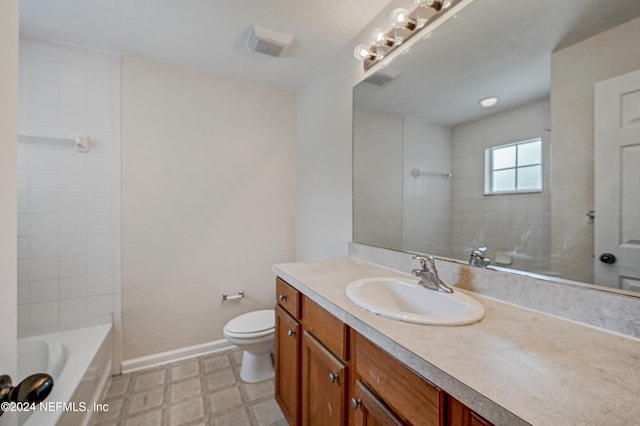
[296,0,415,260]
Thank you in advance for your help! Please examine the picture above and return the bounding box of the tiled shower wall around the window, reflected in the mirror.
[451,99,553,275]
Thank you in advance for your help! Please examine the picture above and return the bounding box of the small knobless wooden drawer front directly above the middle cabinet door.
[302,296,348,361]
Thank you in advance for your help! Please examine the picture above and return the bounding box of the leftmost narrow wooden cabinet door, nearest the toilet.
[275,305,300,426]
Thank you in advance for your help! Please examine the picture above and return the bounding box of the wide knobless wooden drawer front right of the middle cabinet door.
[353,333,446,426]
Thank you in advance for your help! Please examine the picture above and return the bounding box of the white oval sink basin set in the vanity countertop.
[345,278,484,325]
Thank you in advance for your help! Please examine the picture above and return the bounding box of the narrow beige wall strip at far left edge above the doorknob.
[0,0,18,382]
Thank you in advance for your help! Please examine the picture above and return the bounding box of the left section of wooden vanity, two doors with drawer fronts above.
[275,278,349,426]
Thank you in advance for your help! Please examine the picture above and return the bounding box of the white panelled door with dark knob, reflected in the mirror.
[594,70,640,291]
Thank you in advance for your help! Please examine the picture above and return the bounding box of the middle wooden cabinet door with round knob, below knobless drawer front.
[302,331,349,426]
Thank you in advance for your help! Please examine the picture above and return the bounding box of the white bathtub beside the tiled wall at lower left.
[14,324,112,426]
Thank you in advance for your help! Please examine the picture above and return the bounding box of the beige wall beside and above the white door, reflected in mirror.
[551,15,640,282]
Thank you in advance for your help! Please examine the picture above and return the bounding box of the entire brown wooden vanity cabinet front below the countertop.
[275,278,491,426]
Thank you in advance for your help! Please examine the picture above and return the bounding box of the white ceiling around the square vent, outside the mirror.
[20,0,396,90]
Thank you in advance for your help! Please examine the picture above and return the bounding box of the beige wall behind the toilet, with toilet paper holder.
[122,58,296,360]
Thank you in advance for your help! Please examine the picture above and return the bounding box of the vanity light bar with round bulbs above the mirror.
[353,0,462,70]
